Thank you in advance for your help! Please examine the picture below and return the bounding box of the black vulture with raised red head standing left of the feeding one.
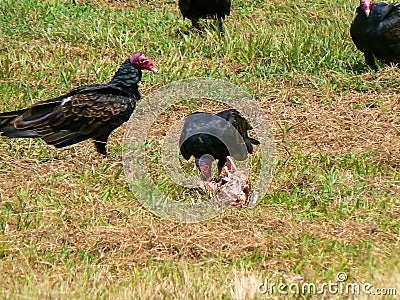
[0,52,157,155]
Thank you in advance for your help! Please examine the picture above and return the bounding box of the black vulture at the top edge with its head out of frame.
[178,0,231,31]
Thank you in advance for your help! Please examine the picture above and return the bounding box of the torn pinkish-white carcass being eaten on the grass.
[204,156,258,208]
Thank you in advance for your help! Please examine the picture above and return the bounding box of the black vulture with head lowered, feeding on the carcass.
[179,109,260,181]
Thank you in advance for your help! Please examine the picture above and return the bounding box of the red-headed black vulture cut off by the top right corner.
[350,0,400,69]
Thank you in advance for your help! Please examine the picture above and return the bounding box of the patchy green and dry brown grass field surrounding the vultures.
[0,0,400,299]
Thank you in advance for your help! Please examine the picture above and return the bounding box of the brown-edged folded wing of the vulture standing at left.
[7,86,135,147]
